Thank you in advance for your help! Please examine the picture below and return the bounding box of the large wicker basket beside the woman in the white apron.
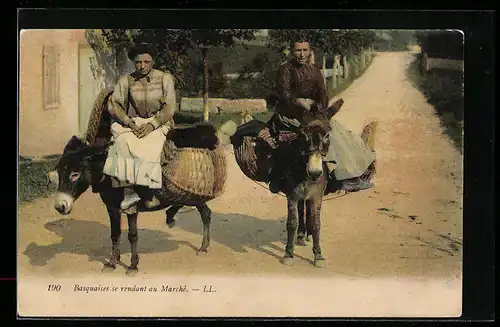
[161,141,227,204]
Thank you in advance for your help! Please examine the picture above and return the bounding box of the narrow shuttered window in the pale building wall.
[43,45,60,110]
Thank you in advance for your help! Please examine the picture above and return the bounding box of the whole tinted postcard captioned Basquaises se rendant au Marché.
[16,29,464,318]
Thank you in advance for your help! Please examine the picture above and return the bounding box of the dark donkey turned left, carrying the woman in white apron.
[49,89,225,274]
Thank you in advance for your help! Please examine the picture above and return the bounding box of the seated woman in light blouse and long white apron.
[104,43,176,210]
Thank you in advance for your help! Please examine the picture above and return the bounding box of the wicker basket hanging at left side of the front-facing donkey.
[234,136,272,182]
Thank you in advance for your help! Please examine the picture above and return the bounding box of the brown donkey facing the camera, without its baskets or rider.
[270,105,343,267]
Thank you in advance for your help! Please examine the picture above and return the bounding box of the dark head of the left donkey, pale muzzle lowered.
[48,136,106,215]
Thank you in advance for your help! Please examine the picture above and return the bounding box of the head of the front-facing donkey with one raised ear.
[298,99,344,180]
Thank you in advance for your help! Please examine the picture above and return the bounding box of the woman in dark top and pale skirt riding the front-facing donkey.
[261,38,375,193]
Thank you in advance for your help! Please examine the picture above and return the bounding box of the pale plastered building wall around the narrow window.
[19,30,82,156]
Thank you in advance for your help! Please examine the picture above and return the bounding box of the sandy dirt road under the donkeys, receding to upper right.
[18,53,462,318]
